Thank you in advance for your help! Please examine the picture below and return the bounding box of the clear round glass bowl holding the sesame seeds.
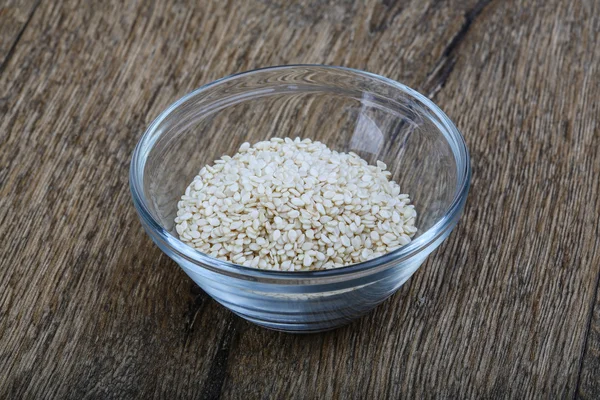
[130,65,471,332]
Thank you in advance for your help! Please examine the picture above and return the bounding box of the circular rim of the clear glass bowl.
[129,64,471,283]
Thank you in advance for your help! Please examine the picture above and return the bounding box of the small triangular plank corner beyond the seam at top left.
[0,0,39,73]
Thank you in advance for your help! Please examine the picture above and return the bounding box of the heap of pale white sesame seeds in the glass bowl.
[175,138,417,271]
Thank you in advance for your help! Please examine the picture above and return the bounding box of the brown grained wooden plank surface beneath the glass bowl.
[0,0,600,399]
